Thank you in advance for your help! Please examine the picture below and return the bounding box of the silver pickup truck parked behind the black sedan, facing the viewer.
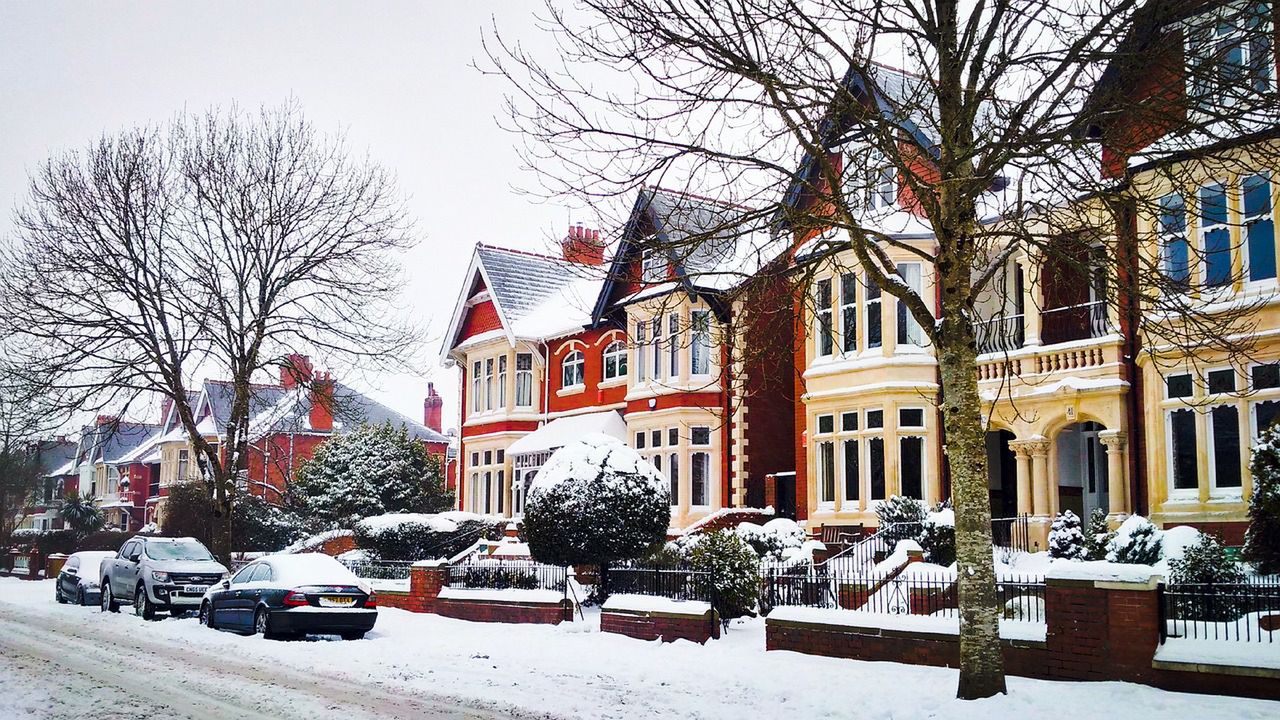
[100,537,230,620]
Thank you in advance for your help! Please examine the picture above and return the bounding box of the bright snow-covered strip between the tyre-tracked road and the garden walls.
[0,578,1280,720]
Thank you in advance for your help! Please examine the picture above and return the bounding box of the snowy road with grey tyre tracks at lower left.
[0,583,545,720]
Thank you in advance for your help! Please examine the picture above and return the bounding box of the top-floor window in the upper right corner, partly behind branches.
[1185,1,1275,119]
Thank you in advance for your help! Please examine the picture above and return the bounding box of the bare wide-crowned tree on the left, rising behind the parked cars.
[0,106,415,557]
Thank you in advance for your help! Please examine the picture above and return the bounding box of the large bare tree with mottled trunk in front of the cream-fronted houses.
[485,0,1276,698]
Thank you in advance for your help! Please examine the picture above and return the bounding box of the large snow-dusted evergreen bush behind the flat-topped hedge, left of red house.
[292,423,453,530]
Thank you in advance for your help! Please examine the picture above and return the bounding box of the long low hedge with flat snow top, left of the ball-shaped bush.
[353,511,507,561]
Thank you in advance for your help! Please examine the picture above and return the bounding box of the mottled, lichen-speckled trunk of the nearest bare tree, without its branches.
[938,298,1006,700]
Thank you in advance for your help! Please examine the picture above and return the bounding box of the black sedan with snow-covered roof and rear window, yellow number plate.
[200,553,378,641]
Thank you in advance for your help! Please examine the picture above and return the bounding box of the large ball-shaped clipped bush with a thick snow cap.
[524,434,671,583]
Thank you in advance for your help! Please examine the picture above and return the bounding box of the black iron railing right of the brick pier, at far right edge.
[1160,579,1280,643]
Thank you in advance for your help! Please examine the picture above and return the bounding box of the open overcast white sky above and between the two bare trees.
[0,0,585,428]
